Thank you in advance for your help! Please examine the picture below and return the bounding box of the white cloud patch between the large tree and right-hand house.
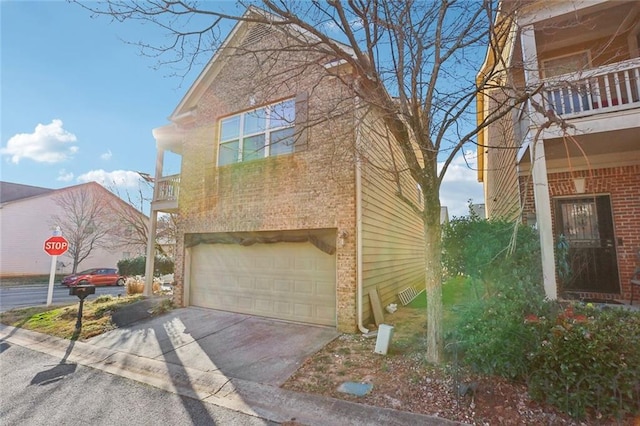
[438,151,484,218]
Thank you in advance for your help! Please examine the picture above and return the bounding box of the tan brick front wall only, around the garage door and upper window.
[169,21,356,332]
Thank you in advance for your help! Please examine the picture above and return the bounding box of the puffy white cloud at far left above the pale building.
[0,119,79,164]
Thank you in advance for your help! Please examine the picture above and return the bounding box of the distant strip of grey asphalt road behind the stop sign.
[0,283,125,312]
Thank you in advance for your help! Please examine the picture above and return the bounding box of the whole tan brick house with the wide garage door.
[147,10,425,332]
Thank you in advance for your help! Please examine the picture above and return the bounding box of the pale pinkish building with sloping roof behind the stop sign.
[0,182,148,277]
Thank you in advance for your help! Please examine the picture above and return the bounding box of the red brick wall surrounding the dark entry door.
[520,165,640,300]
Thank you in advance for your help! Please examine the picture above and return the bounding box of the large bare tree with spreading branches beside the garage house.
[76,0,536,362]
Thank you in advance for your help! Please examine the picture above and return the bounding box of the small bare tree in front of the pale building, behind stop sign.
[52,183,114,273]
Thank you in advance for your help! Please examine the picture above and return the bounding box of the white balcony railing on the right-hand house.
[544,58,640,118]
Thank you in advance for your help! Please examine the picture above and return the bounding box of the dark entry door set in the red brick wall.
[556,195,620,293]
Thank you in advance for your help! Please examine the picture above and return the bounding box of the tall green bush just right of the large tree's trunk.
[443,217,551,379]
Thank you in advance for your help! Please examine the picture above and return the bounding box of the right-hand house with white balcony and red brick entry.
[478,0,640,302]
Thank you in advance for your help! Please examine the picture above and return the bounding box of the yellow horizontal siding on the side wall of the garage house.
[359,110,425,324]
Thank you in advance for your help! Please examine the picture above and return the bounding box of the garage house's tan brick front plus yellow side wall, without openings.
[154,19,425,332]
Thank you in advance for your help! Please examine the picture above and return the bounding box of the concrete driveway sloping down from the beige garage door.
[87,307,338,386]
